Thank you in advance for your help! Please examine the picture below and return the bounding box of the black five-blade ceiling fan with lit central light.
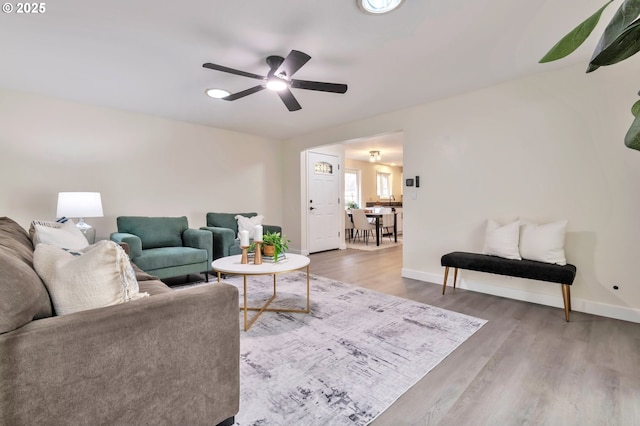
[202,50,347,111]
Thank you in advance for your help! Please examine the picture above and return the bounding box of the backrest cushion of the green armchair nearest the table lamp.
[116,216,189,250]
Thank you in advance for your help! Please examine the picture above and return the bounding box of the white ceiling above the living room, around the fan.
[0,0,600,150]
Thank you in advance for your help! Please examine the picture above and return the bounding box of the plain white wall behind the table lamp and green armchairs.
[0,90,286,238]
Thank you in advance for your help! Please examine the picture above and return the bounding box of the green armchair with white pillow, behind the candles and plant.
[200,212,282,260]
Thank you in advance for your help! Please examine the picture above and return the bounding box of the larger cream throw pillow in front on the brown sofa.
[33,240,149,315]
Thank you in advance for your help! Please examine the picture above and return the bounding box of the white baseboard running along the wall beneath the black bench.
[402,268,640,323]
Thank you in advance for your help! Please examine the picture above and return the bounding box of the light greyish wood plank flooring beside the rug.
[310,247,640,426]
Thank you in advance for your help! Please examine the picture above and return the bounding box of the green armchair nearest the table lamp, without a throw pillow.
[111,216,213,281]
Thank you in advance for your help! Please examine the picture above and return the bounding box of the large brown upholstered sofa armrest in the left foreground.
[0,283,240,425]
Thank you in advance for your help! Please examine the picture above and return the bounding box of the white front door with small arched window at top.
[307,151,341,253]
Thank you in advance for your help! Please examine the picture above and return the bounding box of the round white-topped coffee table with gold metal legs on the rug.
[211,253,311,331]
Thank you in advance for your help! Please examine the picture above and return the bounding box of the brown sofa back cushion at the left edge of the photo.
[0,217,53,334]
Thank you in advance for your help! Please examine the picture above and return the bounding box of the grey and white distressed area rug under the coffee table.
[190,272,486,426]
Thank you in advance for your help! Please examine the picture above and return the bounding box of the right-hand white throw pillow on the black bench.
[520,220,567,265]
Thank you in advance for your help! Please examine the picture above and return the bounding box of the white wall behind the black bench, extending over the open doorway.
[284,61,640,321]
